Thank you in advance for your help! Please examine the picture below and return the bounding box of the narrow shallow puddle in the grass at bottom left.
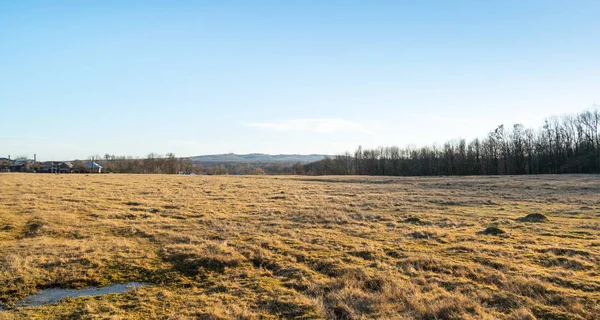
[9,282,146,310]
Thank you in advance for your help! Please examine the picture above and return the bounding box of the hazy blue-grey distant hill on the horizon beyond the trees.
[191,153,327,164]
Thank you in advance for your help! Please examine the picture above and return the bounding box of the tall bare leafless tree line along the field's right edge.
[302,105,600,176]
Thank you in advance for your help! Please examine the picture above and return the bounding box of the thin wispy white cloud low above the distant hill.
[246,119,371,133]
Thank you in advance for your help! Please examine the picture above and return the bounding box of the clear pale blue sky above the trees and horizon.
[0,0,600,160]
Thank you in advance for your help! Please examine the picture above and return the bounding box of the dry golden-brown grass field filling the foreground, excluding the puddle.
[0,174,600,319]
